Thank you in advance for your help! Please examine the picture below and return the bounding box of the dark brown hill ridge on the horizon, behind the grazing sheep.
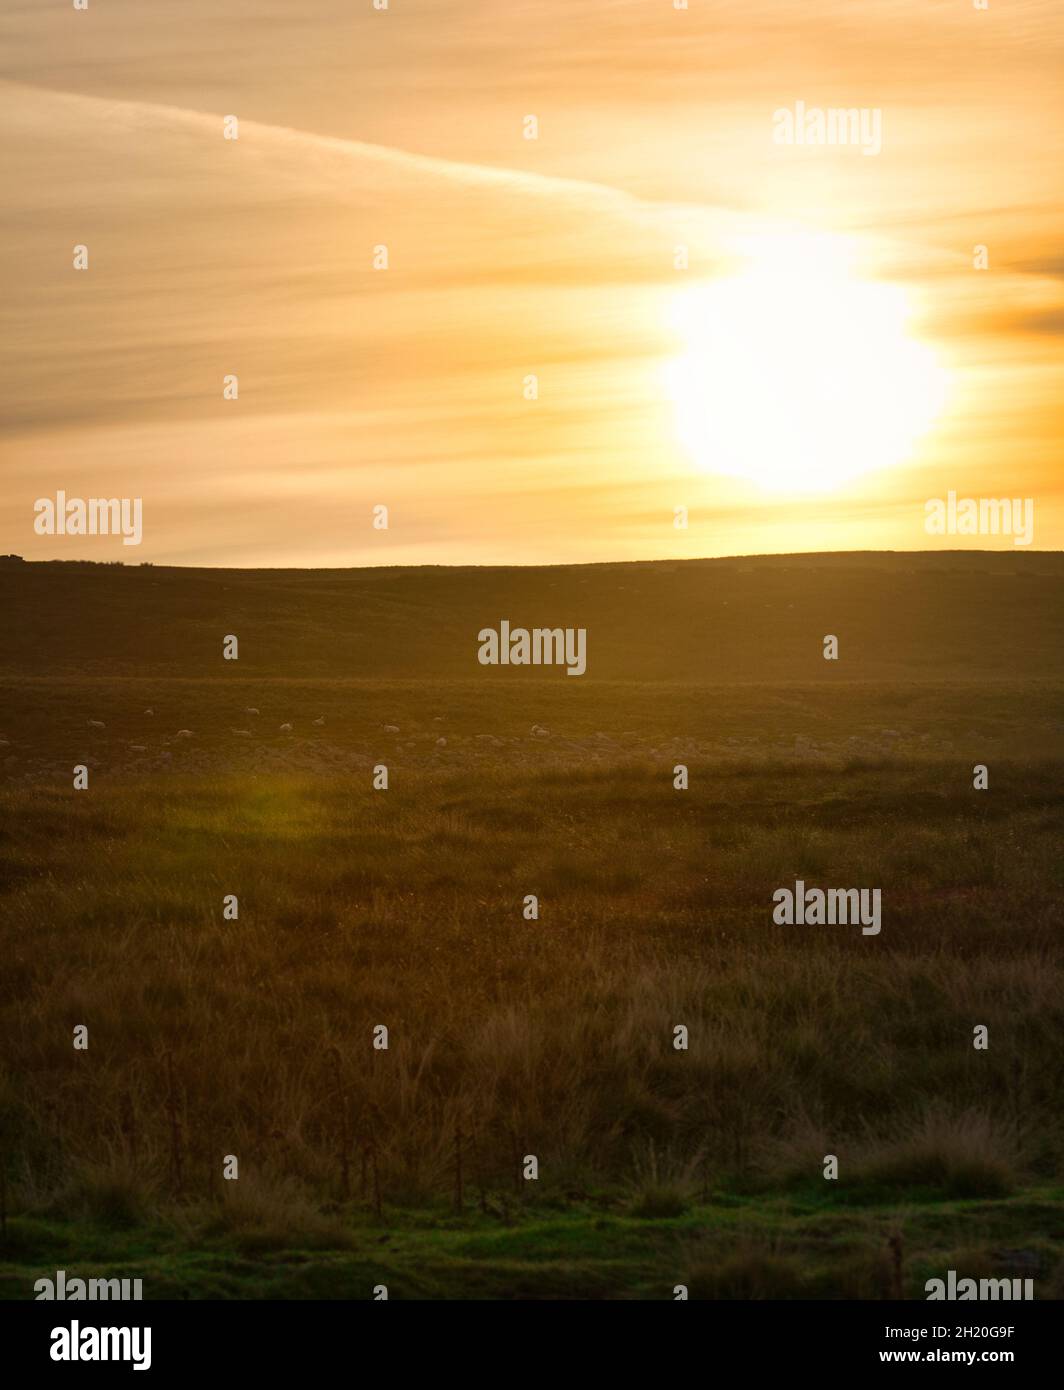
[0,550,1064,685]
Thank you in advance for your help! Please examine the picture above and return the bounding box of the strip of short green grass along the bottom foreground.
[0,1188,1064,1300]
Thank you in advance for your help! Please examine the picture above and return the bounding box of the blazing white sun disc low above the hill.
[665,234,946,492]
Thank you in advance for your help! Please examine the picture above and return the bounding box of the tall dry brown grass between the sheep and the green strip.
[0,762,1064,1228]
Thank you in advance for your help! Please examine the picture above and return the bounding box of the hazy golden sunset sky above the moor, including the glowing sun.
[0,0,1064,566]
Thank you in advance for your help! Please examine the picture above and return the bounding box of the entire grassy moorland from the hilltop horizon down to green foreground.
[0,555,1064,1298]
